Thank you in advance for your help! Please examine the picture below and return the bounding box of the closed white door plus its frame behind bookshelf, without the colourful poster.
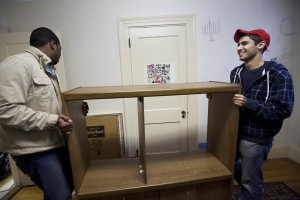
[118,15,198,157]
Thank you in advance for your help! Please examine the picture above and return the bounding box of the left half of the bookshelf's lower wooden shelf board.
[78,157,145,199]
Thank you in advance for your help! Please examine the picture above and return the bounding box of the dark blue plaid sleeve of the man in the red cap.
[245,70,294,121]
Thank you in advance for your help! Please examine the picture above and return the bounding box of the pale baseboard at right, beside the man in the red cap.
[268,145,300,164]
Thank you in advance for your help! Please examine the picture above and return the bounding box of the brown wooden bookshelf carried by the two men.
[63,82,240,200]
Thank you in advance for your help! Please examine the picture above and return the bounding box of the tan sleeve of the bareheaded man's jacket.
[0,59,58,131]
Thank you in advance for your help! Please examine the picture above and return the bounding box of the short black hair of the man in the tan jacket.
[30,27,60,47]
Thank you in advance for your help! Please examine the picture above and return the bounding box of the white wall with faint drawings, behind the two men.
[0,0,300,159]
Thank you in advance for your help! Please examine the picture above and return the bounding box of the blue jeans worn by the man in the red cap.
[234,140,272,200]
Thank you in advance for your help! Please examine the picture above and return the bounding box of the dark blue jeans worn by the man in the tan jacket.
[12,146,74,200]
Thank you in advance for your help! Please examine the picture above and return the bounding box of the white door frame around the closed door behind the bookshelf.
[118,15,198,157]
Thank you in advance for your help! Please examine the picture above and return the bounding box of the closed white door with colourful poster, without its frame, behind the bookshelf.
[129,26,188,154]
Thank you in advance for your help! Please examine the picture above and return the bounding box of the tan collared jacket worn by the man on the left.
[0,47,64,155]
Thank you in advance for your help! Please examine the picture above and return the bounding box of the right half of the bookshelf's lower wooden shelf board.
[148,151,232,186]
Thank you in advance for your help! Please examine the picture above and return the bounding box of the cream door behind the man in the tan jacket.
[0,32,67,186]
